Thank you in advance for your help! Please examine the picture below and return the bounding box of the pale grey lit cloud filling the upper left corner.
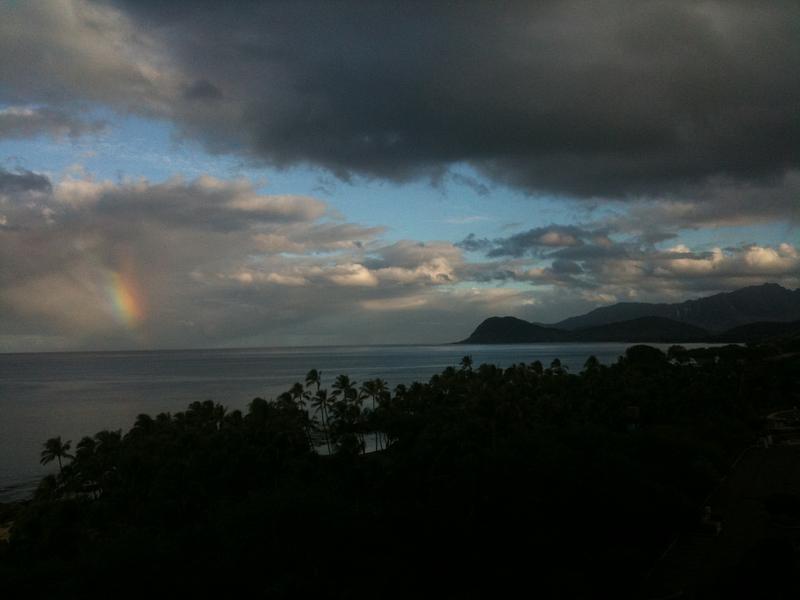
[0,0,175,118]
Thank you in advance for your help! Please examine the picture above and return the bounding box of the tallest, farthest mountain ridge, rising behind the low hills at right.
[552,283,800,332]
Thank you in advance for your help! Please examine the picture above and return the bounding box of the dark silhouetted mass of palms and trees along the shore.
[0,340,800,598]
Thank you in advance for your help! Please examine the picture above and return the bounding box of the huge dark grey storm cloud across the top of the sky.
[98,1,800,197]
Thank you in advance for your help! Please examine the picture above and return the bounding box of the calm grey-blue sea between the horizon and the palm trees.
[0,344,712,502]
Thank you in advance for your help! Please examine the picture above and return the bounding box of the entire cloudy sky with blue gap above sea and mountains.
[0,0,800,352]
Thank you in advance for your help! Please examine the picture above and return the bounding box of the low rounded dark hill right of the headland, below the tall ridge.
[570,317,711,343]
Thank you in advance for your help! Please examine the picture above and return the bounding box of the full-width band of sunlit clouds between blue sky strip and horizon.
[0,169,800,349]
